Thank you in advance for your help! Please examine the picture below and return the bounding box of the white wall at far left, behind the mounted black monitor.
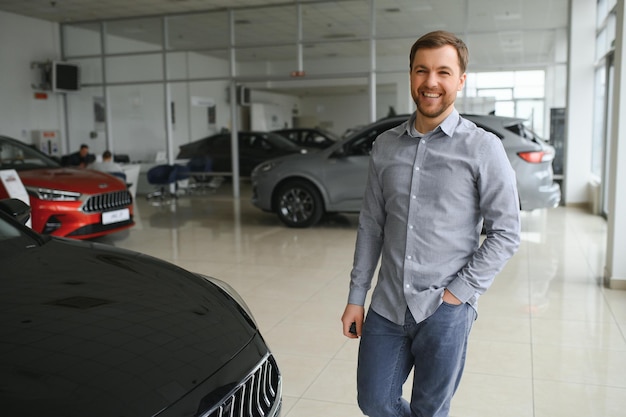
[0,11,65,149]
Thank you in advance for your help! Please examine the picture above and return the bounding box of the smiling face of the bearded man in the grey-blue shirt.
[410,45,466,122]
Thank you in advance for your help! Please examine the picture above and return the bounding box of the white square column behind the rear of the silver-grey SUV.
[562,0,596,205]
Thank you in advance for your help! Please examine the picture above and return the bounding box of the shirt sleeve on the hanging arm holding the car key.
[348,142,385,306]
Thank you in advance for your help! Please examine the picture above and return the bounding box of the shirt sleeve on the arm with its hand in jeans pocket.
[448,136,520,302]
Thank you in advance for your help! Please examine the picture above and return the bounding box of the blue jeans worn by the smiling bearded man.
[357,303,476,417]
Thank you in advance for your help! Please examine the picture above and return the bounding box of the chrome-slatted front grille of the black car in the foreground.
[203,356,280,417]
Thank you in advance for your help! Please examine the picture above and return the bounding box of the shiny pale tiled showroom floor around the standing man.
[102,183,626,417]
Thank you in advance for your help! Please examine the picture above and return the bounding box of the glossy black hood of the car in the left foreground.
[0,239,263,417]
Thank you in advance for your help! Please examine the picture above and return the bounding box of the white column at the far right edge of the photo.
[604,1,626,290]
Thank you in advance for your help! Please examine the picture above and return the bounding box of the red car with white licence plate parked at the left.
[0,136,135,239]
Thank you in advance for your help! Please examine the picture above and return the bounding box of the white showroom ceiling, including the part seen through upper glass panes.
[0,0,569,95]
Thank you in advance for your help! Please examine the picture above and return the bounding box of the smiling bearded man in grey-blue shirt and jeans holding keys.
[341,31,520,417]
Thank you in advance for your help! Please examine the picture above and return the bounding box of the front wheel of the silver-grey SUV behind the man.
[275,180,324,228]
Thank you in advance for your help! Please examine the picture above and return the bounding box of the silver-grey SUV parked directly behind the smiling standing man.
[251,114,561,227]
